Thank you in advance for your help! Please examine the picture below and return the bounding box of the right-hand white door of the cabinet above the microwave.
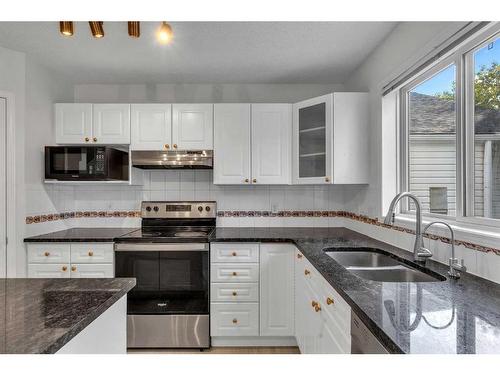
[92,104,130,144]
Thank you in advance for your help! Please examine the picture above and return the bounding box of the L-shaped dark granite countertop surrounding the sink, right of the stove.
[212,228,500,354]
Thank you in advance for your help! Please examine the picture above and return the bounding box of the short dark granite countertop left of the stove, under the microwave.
[24,228,138,242]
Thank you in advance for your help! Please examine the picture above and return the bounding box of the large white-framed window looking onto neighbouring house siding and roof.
[400,24,500,226]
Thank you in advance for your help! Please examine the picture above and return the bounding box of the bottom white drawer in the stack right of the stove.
[210,303,259,336]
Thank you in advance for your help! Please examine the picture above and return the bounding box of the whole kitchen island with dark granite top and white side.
[0,278,135,354]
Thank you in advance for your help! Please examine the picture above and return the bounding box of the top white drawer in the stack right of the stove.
[210,243,259,263]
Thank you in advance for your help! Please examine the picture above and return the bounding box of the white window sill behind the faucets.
[395,214,500,249]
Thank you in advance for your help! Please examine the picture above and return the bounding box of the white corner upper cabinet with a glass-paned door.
[293,93,369,184]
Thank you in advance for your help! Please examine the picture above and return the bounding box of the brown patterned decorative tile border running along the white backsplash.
[25,211,500,255]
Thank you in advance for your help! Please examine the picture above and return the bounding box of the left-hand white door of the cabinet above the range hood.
[130,104,172,150]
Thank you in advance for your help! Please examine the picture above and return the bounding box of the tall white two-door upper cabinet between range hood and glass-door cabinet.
[214,104,292,185]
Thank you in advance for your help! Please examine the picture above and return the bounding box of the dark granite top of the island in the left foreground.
[0,278,135,354]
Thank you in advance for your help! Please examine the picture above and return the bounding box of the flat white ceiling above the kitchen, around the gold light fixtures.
[0,22,396,83]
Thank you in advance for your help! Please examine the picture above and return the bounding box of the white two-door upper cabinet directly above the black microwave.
[55,103,130,144]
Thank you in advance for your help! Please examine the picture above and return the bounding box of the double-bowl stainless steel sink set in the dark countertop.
[324,249,446,282]
